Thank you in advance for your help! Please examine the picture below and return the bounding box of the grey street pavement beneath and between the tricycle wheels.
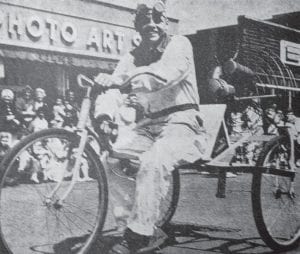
[0,168,300,254]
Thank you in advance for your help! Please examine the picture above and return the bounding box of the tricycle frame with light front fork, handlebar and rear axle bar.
[48,72,296,203]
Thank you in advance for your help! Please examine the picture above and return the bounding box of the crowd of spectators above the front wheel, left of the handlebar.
[0,86,78,161]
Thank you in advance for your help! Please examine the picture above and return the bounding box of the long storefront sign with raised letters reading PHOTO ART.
[0,6,139,59]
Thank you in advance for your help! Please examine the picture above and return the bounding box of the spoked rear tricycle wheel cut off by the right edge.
[252,136,300,251]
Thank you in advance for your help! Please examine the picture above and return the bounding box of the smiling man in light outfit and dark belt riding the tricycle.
[95,0,206,254]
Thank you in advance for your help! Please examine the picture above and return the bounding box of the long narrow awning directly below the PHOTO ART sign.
[0,48,117,72]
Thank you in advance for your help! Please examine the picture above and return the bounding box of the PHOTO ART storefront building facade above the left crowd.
[0,0,178,100]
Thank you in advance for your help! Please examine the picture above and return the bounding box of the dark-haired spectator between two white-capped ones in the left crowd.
[16,86,35,127]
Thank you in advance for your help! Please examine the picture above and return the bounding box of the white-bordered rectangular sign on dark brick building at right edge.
[280,40,300,66]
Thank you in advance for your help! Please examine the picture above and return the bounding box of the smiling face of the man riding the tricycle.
[136,7,167,43]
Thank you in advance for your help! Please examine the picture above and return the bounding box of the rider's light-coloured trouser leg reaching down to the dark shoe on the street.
[128,124,205,236]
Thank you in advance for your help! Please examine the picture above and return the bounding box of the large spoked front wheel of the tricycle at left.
[0,129,108,254]
